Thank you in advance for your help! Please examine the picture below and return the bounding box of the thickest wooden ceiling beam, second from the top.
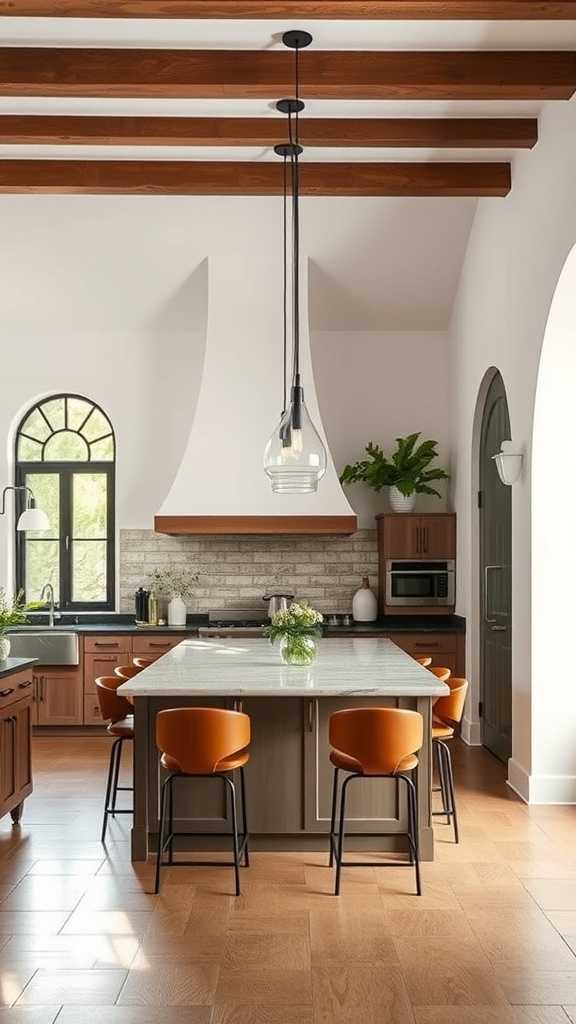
[0,47,576,100]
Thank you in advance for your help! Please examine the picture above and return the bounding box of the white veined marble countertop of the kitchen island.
[118,637,449,697]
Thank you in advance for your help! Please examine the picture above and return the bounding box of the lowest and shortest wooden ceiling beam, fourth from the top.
[0,160,510,196]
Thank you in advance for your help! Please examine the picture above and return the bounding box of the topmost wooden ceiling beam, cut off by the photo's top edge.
[0,0,576,20]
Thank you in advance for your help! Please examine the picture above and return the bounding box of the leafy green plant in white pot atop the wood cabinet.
[340,432,448,512]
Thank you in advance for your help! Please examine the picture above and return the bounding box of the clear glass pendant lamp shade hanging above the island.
[264,387,326,495]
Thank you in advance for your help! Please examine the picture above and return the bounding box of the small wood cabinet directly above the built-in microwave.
[376,512,456,560]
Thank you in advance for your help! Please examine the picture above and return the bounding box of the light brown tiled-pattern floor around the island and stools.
[0,736,576,1024]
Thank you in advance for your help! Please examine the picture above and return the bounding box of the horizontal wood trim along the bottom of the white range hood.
[154,515,358,537]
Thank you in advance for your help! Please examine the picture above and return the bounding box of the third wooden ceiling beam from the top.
[0,114,538,150]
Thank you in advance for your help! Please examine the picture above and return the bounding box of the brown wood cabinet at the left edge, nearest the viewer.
[0,671,33,821]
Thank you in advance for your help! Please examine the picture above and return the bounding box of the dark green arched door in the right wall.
[480,373,512,761]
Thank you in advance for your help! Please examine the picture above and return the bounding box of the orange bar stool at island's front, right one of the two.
[329,708,423,896]
